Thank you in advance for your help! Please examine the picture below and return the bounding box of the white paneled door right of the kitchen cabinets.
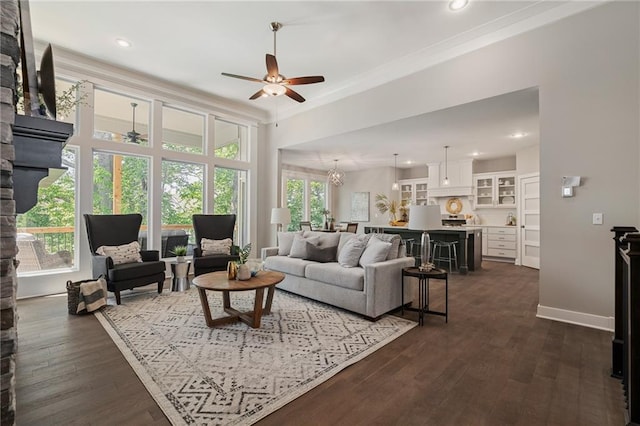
[519,173,540,269]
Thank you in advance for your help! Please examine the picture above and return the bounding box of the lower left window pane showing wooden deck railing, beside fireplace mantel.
[17,147,76,276]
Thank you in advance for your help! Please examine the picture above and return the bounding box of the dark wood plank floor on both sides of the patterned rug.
[16,262,624,426]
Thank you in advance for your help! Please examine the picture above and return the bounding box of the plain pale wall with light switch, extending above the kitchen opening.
[267,2,640,327]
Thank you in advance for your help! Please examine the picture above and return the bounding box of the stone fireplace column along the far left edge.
[0,0,20,425]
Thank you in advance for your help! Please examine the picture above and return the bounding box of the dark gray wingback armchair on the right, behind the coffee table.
[192,214,240,276]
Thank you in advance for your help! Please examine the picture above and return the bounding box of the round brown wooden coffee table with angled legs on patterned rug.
[193,271,284,328]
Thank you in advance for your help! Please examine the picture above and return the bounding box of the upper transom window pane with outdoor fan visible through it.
[93,89,151,145]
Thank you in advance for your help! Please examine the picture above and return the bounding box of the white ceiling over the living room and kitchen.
[30,0,599,169]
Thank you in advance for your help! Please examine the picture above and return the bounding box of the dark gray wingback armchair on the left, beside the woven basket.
[84,214,165,305]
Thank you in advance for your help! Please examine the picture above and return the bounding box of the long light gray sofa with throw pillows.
[262,231,415,320]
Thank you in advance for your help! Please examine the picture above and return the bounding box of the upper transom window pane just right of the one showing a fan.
[162,107,204,154]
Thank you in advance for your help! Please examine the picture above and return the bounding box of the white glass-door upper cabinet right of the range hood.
[473,172,516,208]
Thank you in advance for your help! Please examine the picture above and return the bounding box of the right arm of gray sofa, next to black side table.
[364,257,415,318]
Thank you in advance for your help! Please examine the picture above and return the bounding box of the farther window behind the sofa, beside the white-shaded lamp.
[284,173,328,231]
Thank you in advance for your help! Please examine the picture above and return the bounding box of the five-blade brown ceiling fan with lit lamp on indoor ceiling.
[222,22,324,102]
